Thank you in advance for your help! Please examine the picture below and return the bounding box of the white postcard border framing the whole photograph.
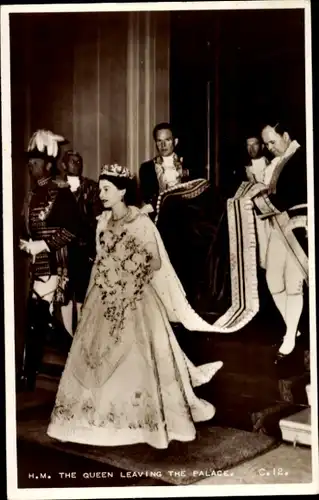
[1,0,319,500]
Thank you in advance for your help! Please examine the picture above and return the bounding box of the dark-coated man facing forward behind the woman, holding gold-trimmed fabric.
[139,123,225,313]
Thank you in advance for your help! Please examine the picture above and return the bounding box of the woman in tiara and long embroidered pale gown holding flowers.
[47,165,222,448]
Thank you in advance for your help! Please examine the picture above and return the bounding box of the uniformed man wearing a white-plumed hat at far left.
[20,130,79,390]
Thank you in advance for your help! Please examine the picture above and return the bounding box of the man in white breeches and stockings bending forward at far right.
[262,121,308,358]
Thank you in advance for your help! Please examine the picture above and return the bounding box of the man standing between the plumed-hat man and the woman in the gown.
[61,150,103,335]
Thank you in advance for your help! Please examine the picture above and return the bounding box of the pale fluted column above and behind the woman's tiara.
[127,12,170,178]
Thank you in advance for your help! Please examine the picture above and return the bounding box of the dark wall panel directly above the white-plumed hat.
[26,14,73,145]
